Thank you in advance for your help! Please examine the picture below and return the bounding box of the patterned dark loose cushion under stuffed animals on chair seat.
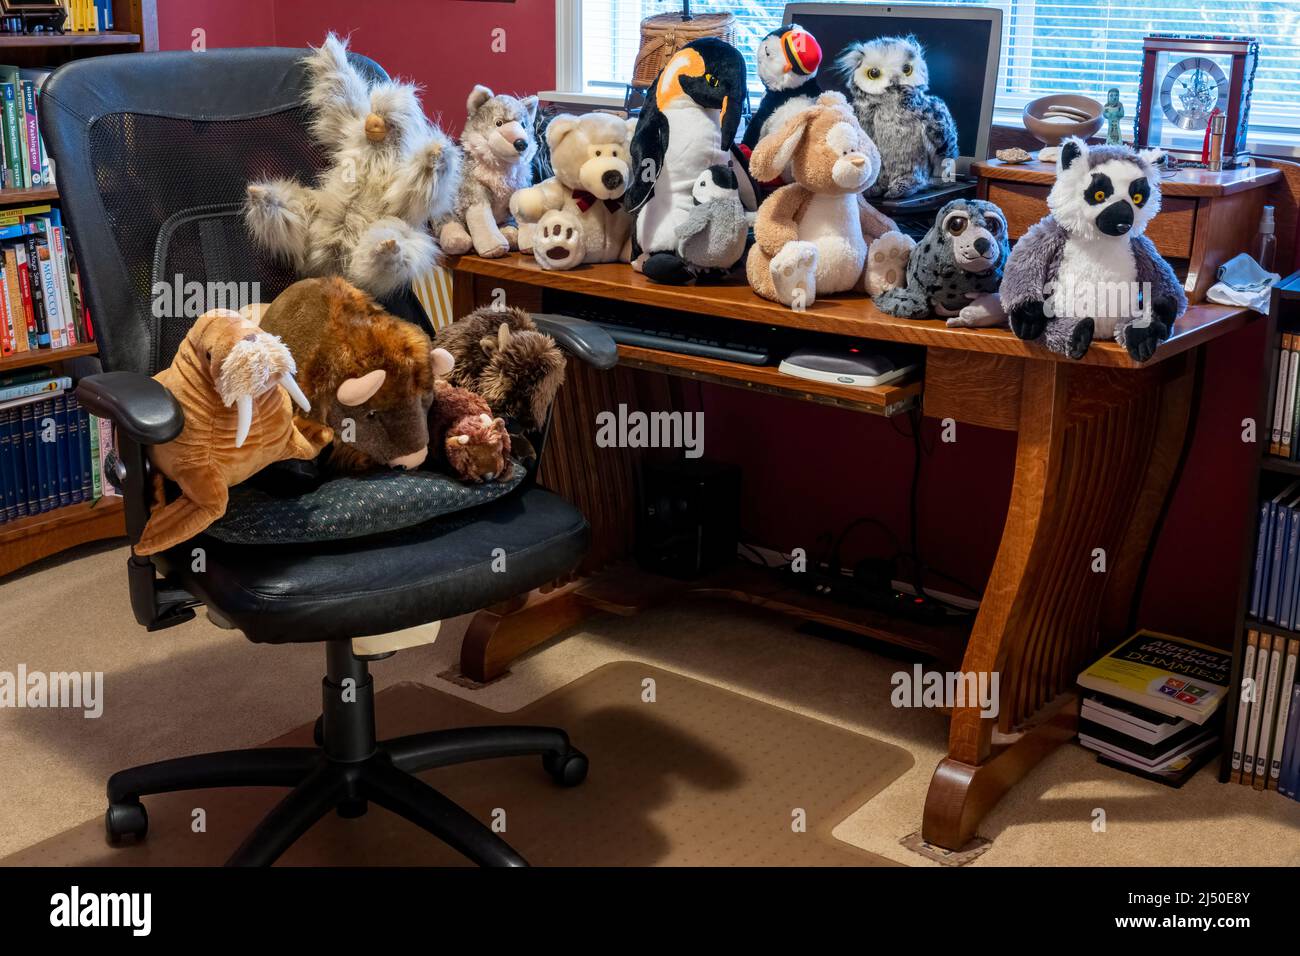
[207,462,527,545]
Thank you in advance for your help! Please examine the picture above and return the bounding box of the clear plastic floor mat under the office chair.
[0,661,913,866]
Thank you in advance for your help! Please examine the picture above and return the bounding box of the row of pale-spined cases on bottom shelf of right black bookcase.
[1231,630,1300,800]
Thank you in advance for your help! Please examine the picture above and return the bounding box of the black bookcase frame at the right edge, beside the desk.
[1219,272,1300,783]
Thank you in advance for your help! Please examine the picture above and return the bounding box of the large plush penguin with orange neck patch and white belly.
[624,36,757,285]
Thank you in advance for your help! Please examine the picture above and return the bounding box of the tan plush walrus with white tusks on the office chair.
[135,308,333,555]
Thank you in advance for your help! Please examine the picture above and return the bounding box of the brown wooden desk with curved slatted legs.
[454,255,1252,849]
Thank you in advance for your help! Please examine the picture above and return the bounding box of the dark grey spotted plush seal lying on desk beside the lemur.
[875,199,1011,328]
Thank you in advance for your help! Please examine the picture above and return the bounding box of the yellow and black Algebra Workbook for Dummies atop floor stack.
[1079,631,1232,724]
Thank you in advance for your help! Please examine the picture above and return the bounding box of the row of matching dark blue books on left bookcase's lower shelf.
[0,368,117,524]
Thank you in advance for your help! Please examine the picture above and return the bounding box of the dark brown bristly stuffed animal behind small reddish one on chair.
[434,306,564,434]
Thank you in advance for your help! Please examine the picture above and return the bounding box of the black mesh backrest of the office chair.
[40,48,387,375]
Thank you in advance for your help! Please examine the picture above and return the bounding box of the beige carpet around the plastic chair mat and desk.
[0,538,1300,866]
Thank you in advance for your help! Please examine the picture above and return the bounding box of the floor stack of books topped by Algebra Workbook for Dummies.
[1079,631,1232,787]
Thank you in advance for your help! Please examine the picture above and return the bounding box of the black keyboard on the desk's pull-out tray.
[542,290,787,365]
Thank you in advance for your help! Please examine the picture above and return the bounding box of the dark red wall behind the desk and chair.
[159,0,1264,644]
